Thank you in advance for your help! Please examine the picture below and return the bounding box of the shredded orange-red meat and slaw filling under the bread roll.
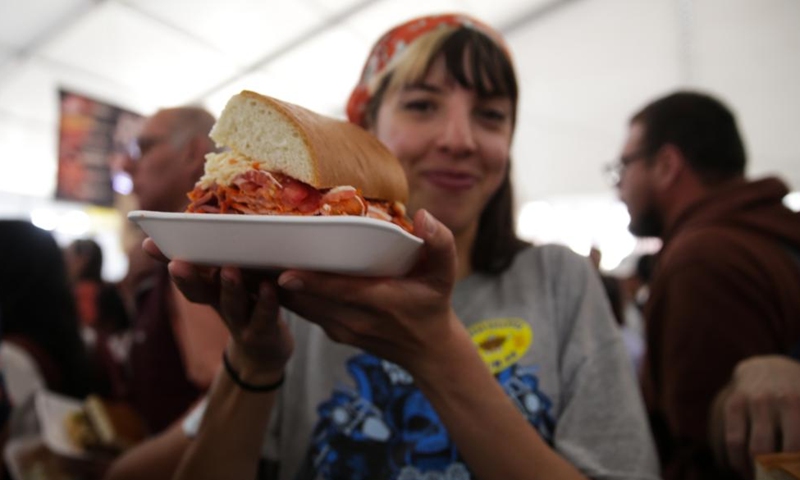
[186,151,412,232]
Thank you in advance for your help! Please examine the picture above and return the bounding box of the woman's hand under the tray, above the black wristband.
[143,238,294,376]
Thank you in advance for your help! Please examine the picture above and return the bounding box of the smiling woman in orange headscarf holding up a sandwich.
[111,15,657,479]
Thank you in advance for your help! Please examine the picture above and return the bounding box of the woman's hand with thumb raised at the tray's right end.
[278,211,464,375]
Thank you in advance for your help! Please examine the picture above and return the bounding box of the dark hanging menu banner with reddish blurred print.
[56,89,144,207]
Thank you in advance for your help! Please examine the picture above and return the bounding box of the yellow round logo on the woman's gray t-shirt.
[468,318,533,375]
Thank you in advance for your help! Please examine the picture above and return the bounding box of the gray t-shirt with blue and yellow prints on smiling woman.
[185,246,658,480]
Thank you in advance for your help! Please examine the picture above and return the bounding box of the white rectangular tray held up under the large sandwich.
[128,210,422,277]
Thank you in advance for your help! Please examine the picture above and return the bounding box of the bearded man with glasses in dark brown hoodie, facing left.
[615,92,800,480]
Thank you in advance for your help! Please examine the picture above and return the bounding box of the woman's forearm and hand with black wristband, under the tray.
[170,262,294,480]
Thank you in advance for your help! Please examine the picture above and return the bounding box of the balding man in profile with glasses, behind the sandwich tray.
[124,107,228,434]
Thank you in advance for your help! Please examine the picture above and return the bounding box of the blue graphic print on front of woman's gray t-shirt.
[310,354,554,480]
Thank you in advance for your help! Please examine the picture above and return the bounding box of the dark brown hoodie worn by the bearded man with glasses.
[642,178,800,480]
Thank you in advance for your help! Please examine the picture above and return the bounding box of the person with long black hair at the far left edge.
[0,220,96,403]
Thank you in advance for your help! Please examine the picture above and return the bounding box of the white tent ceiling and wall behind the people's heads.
[0,0,800,274]
